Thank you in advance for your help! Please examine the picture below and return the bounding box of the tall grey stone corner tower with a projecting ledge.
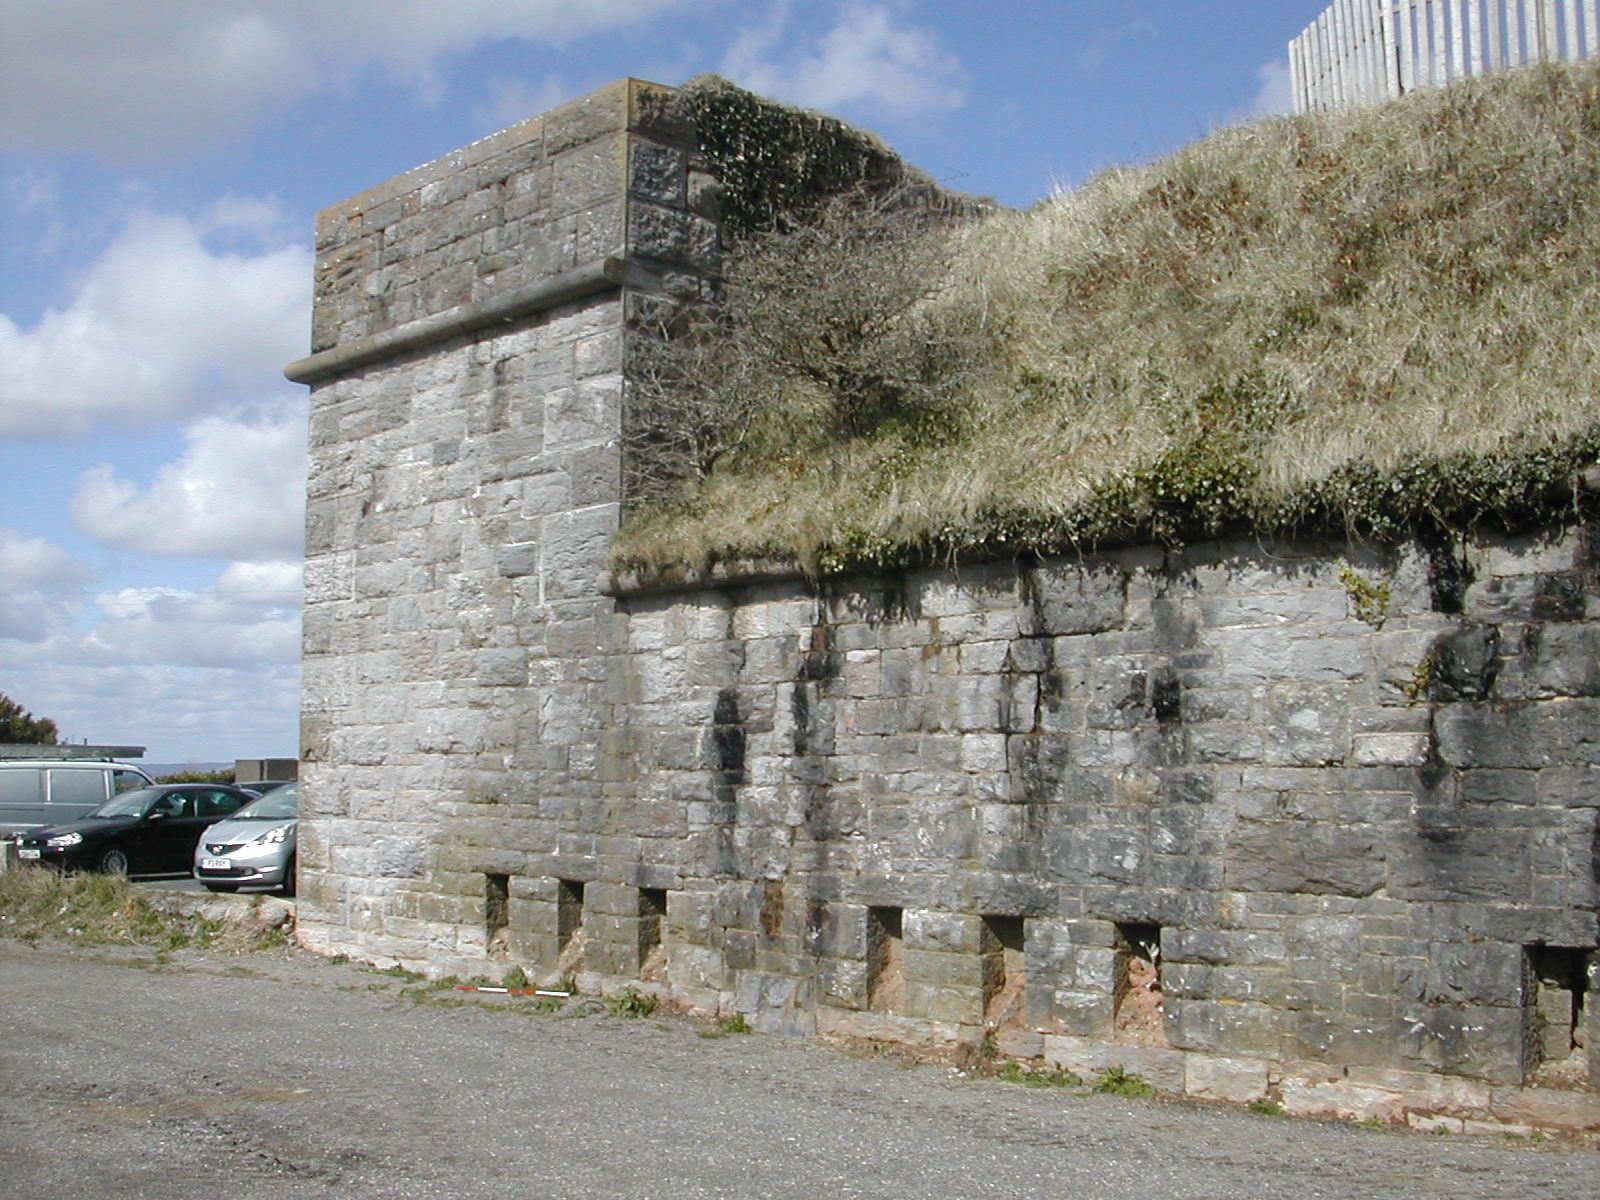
[288,80,718,971]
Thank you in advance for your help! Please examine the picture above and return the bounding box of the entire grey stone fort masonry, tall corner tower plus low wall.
[294,80,1600,1130]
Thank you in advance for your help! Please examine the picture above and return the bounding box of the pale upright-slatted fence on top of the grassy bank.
[1290,0,1600,112]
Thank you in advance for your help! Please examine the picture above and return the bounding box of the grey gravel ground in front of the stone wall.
[0,939,1600,1200]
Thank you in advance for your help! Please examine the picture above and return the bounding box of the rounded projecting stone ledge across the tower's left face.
[283,254,627,384]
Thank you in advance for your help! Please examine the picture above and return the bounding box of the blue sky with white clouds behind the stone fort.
[0,0,1325,763]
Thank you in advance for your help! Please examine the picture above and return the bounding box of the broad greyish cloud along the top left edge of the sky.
[0,0,683,158]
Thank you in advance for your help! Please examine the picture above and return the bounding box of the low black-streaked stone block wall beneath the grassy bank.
[572,531,1600,1125]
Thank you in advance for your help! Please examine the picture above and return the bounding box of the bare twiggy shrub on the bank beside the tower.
[626,184,978,518]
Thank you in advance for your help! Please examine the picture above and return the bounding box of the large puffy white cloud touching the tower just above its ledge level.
[0,209,312,437]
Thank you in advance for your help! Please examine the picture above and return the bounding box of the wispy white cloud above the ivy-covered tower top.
[722,0,966,117]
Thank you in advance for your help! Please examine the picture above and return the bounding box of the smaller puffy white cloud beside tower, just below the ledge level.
[72,400,306,560]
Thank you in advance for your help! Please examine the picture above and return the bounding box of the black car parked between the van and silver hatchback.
[18,784,256,875]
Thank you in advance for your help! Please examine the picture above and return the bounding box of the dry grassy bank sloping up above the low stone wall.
[614,64,1600,571]
